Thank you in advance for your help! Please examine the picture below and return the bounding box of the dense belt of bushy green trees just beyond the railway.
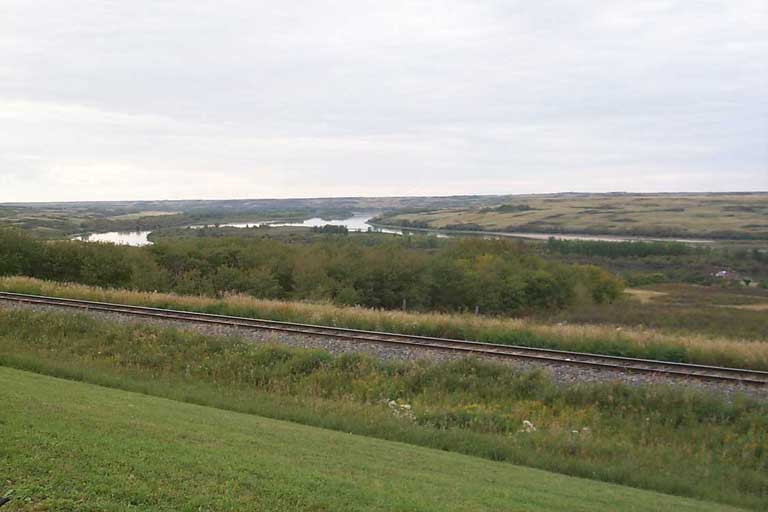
[0,230,623,314]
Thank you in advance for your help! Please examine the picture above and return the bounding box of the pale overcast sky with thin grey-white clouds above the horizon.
[0,0,768,202]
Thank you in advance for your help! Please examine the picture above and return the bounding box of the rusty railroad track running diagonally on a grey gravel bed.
[0,292,768,386]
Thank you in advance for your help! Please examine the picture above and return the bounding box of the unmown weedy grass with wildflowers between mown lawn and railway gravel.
[0,311,768,510]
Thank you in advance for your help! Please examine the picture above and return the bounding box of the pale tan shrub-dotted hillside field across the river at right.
[378,193,768,240]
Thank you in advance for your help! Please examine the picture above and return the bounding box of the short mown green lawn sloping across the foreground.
[0,368,735,512]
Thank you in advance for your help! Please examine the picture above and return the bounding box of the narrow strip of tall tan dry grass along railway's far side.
[0,277,768,370]
